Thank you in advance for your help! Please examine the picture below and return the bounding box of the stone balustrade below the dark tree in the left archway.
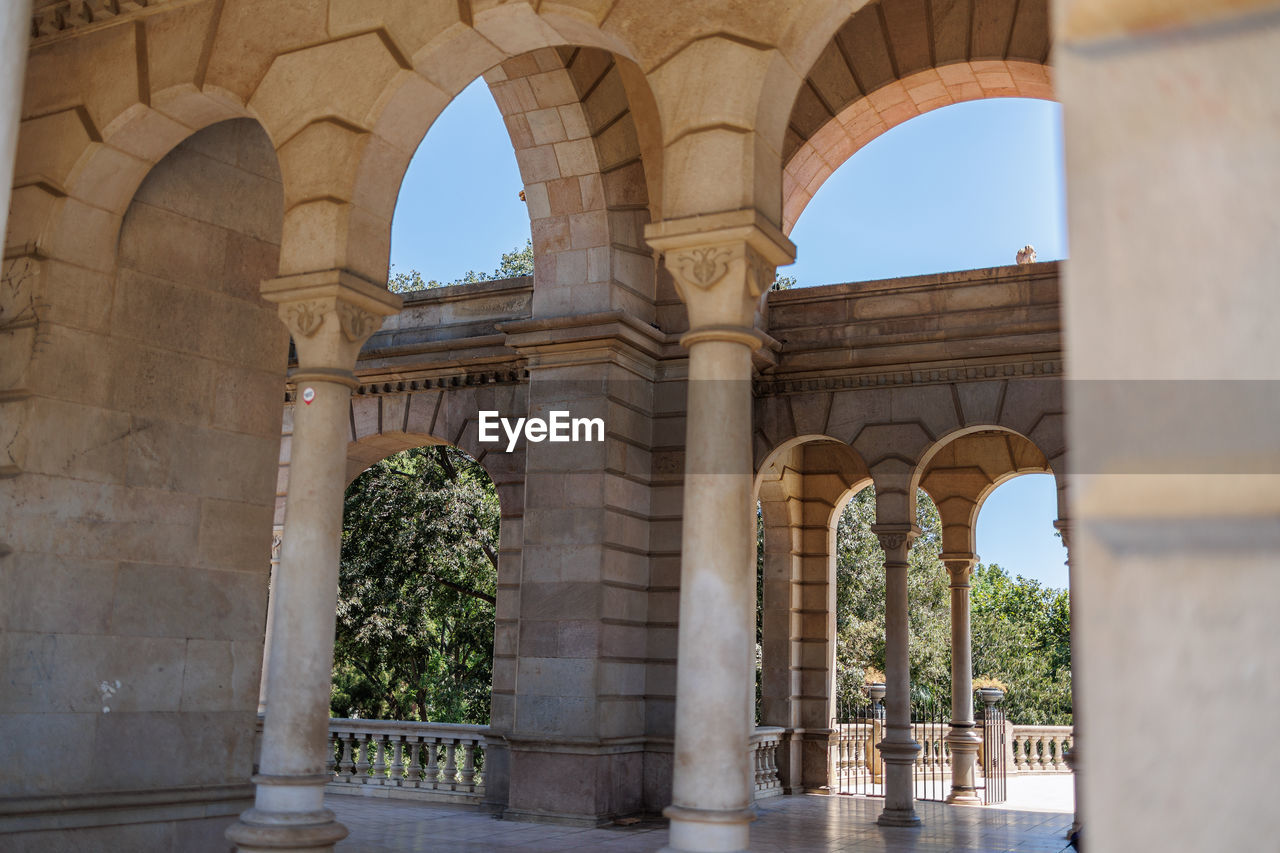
[325,720,486,802]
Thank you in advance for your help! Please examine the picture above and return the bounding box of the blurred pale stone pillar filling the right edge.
[1053,0,1280,853]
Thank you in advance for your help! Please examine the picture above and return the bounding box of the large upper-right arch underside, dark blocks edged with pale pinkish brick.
[782,0,1053,233]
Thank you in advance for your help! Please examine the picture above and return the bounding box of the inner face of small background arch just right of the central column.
[756,435,870,792]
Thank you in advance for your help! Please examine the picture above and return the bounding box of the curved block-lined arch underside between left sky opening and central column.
[484,46,675,323]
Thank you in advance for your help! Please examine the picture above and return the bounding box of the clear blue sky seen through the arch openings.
[392,81,1066,587]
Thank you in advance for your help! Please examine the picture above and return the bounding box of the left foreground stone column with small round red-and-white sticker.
[227,270,401,853]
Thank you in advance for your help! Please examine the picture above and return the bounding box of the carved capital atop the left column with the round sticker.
[261,269,403,371]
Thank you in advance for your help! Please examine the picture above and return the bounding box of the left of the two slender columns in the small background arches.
[872,524,920,826]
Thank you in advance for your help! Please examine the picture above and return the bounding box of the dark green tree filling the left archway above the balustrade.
[330,446,499,724]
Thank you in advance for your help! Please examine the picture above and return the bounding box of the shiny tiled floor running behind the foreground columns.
[325,795,1071,853]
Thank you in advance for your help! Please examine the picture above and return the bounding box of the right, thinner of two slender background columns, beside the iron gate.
[942,553,982,806]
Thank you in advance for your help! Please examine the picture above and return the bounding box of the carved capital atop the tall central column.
[645,209,795,330]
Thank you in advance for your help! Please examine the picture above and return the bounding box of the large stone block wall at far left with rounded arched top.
[0,120,288,850]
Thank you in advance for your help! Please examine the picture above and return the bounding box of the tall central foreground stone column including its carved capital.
[645,210,794,850]
